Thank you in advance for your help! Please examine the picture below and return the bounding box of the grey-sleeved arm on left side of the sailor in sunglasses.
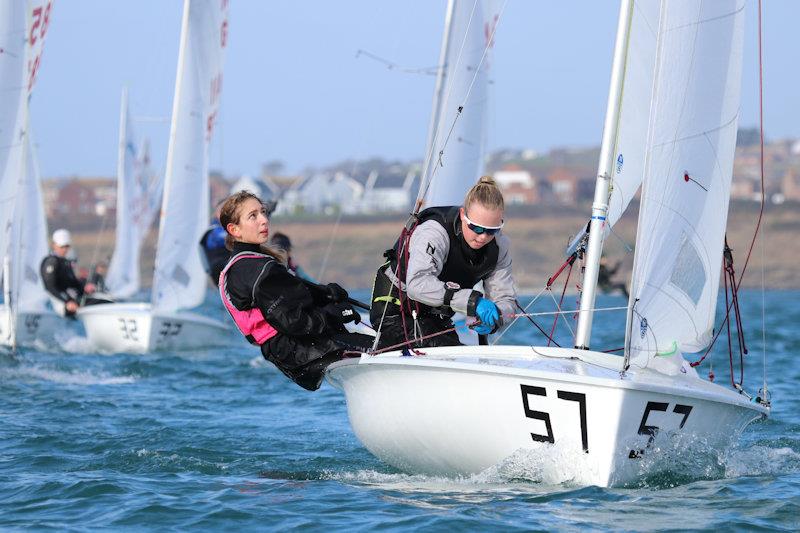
[406,221,481,316]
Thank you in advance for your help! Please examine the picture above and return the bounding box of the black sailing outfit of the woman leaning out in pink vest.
[220,242,373,390]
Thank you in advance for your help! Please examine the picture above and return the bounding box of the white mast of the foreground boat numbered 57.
[575,0,633,350]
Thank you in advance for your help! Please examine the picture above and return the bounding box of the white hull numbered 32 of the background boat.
[78,303,231,353]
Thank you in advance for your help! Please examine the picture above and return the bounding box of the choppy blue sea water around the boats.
[0,291,800,531]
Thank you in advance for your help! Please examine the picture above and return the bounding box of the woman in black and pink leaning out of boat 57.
[219,191,373,390]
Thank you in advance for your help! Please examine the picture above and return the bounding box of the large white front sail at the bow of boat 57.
[628,0,744,362]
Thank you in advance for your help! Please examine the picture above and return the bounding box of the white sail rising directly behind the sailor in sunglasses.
[423,0,500,207]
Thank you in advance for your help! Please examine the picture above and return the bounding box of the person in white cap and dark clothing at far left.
[40,228,95,316]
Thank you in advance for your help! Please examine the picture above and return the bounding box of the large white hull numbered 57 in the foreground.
[327,346,768,486]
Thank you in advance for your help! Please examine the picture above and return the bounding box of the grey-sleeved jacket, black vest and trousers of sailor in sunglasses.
[370,206,516,347]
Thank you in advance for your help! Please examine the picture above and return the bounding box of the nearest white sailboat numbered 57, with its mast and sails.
[327,0,770,486]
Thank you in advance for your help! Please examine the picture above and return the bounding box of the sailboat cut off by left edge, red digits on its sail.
[0,0,61,349]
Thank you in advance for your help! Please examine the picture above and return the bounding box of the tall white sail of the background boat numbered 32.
[152,0,228,310]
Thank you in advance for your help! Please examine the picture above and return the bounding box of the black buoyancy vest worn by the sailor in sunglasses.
[373,206,500,314]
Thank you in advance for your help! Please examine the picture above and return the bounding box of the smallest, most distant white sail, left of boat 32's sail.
[106,91,162,298]
